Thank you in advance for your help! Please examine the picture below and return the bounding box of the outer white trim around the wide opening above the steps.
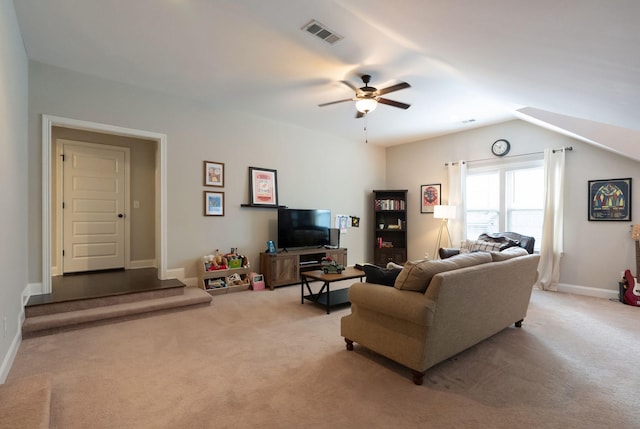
[42,114,167,294]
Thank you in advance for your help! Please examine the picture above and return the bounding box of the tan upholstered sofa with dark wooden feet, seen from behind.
[340,250,539,384]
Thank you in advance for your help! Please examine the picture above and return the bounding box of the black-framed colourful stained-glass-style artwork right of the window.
[589,178,631,222]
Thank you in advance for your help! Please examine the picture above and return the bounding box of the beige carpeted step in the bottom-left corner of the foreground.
[0,374,52,429]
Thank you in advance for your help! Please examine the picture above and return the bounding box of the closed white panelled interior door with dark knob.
[62,143,126,273]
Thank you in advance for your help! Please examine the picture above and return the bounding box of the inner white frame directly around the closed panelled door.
[51,139,131,276]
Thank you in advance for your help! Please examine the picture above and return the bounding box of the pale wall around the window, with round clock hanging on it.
[386,120,640,293]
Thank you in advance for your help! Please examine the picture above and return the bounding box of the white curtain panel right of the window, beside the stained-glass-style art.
[536,149,565,290]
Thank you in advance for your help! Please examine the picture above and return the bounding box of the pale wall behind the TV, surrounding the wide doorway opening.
[29,63,386,283]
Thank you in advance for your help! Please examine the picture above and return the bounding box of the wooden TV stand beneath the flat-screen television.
[260,247,347,290]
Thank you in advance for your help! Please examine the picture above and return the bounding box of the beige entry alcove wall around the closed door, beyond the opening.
[51,127,157,266]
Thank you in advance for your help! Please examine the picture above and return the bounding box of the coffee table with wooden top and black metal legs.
[300,267,365,314]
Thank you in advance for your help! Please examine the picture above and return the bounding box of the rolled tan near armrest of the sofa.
[349,283,436,326]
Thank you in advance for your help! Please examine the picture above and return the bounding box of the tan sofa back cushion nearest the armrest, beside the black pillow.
[394,252,491,292]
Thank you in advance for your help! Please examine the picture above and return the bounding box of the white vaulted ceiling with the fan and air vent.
[14,0,640,153]
